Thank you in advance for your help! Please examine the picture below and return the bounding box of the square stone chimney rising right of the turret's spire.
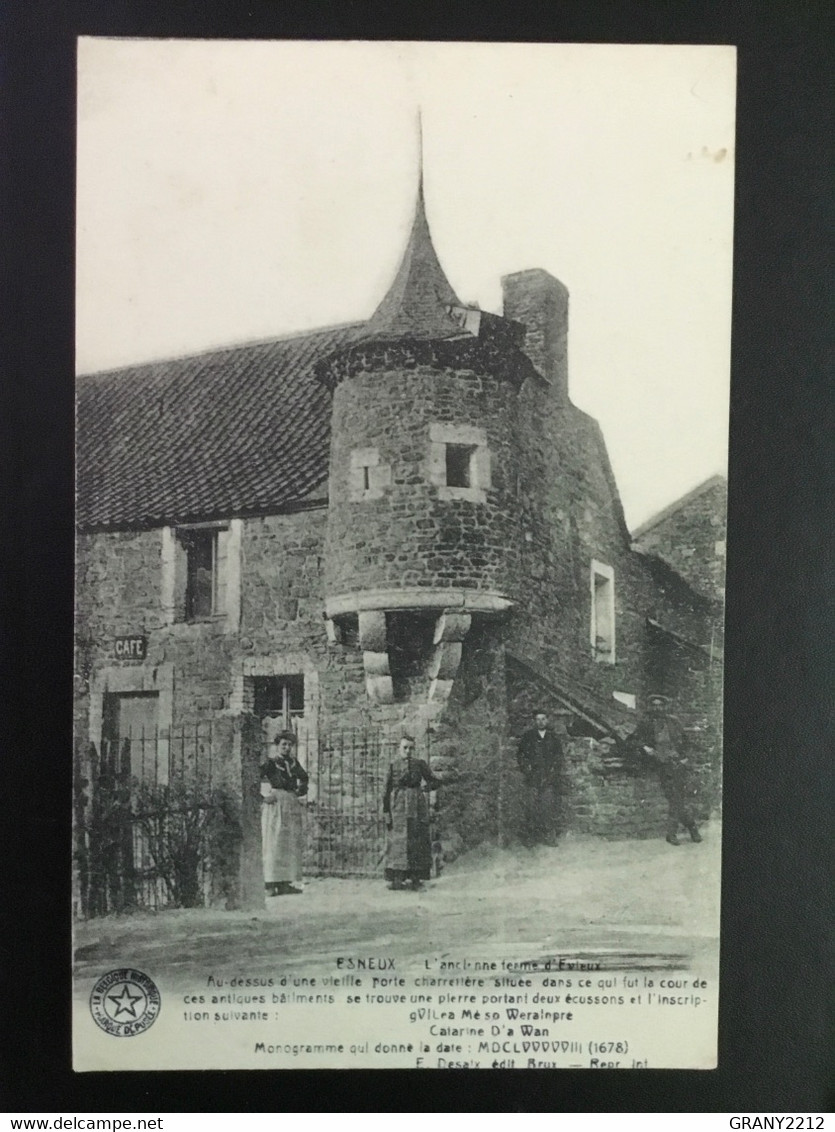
[501,267,568,401]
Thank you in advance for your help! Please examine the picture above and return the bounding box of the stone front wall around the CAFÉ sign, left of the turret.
[76,508,384,741]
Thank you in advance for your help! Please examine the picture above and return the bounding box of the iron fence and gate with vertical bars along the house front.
[75,720,430,917]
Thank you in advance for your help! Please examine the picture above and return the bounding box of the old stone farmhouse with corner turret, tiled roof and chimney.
[76,176,723,852]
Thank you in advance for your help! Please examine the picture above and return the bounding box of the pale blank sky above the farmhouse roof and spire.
[76,38,735,528]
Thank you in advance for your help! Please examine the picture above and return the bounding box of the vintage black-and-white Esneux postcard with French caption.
[74,38,735,1071]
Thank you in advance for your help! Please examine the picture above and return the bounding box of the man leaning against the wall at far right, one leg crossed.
[627,692,701,846]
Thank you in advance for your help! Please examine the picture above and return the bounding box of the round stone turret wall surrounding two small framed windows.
[325,367,518,595]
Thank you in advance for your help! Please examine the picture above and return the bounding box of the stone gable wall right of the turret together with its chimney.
[503,271,712,724]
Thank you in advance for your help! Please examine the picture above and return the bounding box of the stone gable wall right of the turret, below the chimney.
[500,388,709,715]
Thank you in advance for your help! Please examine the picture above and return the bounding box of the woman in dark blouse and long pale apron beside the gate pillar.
[261,731,308,897]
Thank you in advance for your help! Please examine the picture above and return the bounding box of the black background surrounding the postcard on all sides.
[0,0,835,1114]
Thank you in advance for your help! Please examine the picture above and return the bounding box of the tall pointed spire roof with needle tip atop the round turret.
[362,110,463,338]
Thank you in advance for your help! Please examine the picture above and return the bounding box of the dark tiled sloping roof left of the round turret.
[76,324,362,529]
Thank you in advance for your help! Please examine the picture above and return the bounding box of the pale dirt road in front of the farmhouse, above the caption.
[76,823,720,981]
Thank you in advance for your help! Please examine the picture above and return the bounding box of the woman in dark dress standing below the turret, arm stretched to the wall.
[382,735,441,889]
